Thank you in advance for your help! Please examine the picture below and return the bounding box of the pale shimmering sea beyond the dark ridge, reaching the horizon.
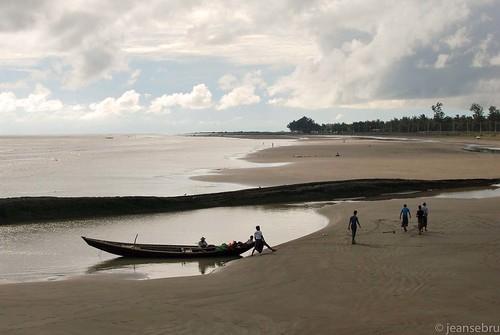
[0,135,294,198]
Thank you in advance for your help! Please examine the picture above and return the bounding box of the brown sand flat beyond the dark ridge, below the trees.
[195,138,500,186]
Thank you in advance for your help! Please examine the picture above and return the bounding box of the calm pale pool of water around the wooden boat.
[0,206,327,282]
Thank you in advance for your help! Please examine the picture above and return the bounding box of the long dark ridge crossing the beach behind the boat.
[0,179,500,225]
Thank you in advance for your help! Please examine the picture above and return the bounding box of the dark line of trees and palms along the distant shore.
[287,102,500,134]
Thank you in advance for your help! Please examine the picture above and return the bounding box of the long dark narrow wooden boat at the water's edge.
[82,236,254,258]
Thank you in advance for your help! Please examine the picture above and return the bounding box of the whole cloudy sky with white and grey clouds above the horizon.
[0,0,500,134]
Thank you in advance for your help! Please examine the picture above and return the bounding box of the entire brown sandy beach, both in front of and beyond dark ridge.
[0,140,500,334]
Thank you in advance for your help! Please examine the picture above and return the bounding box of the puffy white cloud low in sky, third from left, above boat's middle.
[149,84,212,113]
